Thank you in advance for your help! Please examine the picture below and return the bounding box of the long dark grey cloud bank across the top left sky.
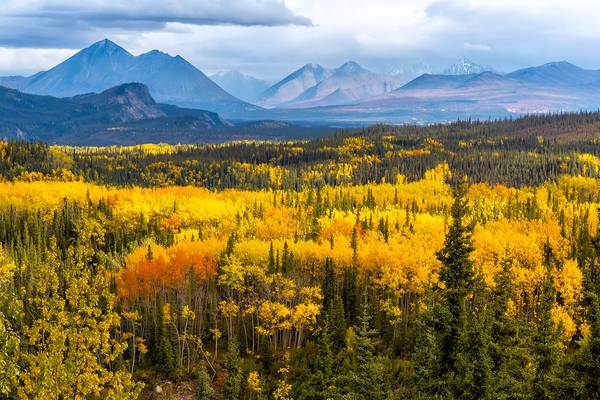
[0,0,312,47]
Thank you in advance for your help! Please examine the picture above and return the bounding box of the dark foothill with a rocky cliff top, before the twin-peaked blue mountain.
[0,83,230,143]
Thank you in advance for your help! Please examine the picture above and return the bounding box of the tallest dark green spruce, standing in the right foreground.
[414,180,490,399]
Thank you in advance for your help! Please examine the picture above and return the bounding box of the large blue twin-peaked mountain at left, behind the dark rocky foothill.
[9,39,257,115]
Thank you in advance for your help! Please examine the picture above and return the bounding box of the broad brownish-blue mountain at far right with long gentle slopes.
[304,61,600,123]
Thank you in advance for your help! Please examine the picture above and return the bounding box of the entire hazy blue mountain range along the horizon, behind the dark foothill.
[0,40,600,130]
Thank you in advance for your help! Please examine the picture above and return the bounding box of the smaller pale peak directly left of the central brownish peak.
[257,64,333,107]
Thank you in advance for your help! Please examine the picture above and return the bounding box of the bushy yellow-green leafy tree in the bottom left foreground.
[18,234,140,399]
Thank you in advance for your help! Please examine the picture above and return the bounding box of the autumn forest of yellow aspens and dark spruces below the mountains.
[0,113,600,400]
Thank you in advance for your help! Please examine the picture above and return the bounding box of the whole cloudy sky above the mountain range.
[0,0,600,80]
